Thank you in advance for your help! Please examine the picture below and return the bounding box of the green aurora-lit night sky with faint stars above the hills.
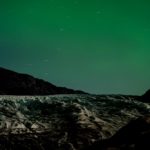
[0,0,150,95]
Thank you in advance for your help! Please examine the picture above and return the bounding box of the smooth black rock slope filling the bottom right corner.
[87,116,150,150]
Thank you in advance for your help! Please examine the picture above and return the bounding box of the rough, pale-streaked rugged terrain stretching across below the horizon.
[0,94,150,150]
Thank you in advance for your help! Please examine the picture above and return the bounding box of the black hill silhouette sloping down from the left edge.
[0,67,85,95]
